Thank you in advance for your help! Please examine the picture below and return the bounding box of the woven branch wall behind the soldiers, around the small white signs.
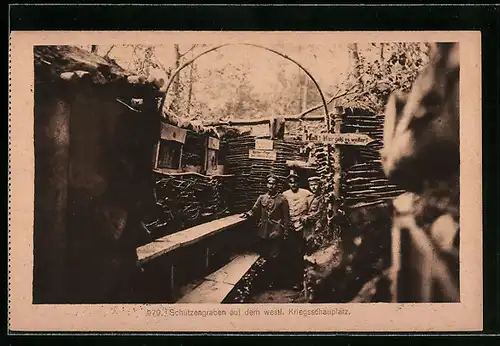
[225,135,302,212]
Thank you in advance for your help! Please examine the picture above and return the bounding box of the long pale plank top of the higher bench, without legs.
[137,214,246,264]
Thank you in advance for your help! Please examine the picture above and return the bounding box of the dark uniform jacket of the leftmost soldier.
[250,193,290,239]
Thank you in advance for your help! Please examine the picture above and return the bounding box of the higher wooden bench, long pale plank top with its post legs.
[137,214,246,300]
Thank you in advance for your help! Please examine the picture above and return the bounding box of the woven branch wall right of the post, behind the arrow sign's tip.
[342,110,404,208]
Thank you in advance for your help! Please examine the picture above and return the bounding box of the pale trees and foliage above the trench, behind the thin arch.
[88,43,429,122]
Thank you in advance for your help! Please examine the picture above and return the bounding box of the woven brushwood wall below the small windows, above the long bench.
[146,173,233,237]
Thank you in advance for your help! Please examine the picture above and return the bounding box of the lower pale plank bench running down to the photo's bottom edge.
[177,253,259,304]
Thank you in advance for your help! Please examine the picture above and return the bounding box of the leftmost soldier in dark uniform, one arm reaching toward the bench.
[243,175,290,286]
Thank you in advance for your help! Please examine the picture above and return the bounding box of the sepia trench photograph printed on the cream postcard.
[7,33,481,332]
